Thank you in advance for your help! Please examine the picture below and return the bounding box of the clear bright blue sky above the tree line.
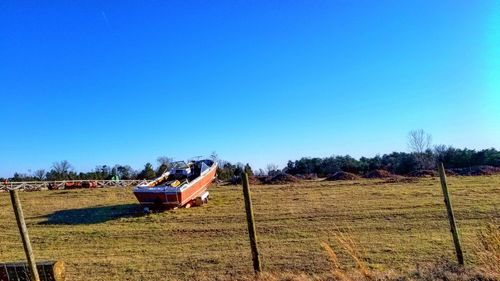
[0,0,500,176]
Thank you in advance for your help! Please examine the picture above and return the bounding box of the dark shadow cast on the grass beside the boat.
[40,204,144,224]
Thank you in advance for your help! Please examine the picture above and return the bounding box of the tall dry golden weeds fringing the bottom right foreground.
[224,229,500,281]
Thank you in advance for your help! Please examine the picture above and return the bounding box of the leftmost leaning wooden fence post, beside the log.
[9,189,40,281]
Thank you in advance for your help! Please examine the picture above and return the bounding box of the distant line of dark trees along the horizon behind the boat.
[4,129,500,181]
